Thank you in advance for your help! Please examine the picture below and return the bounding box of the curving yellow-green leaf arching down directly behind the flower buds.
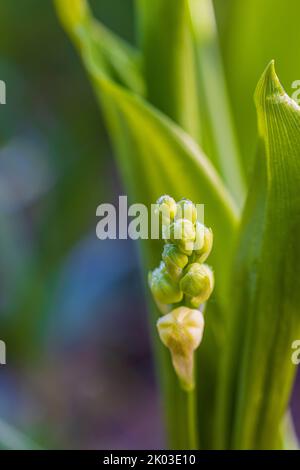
[55,0,238,448]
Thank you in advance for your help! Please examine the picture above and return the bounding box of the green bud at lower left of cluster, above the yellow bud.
[149,262,183,304]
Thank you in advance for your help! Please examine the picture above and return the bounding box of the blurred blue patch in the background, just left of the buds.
[50,237,138,341]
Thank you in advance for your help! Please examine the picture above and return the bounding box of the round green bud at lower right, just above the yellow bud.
[180,263,214,308]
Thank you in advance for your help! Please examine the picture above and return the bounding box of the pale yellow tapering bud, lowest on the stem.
[157,307,204,391]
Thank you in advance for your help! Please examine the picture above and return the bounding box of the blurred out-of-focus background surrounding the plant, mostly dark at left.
[0,0,300,449]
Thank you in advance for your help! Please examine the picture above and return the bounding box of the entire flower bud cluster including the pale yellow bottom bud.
[149,196,214,390]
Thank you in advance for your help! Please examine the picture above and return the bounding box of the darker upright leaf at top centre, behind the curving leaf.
[136,0,200,140]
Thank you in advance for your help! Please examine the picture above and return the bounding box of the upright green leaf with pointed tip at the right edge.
[218,62,300,449]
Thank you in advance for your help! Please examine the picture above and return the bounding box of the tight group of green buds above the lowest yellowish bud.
[149,196,214,308]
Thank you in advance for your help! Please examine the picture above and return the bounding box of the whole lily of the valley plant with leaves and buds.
[55,0,300,449]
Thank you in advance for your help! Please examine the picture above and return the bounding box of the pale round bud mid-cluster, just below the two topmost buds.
[170,219,196,256]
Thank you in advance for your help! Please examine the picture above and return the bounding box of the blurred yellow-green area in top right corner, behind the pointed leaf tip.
[215,0,300,173]
